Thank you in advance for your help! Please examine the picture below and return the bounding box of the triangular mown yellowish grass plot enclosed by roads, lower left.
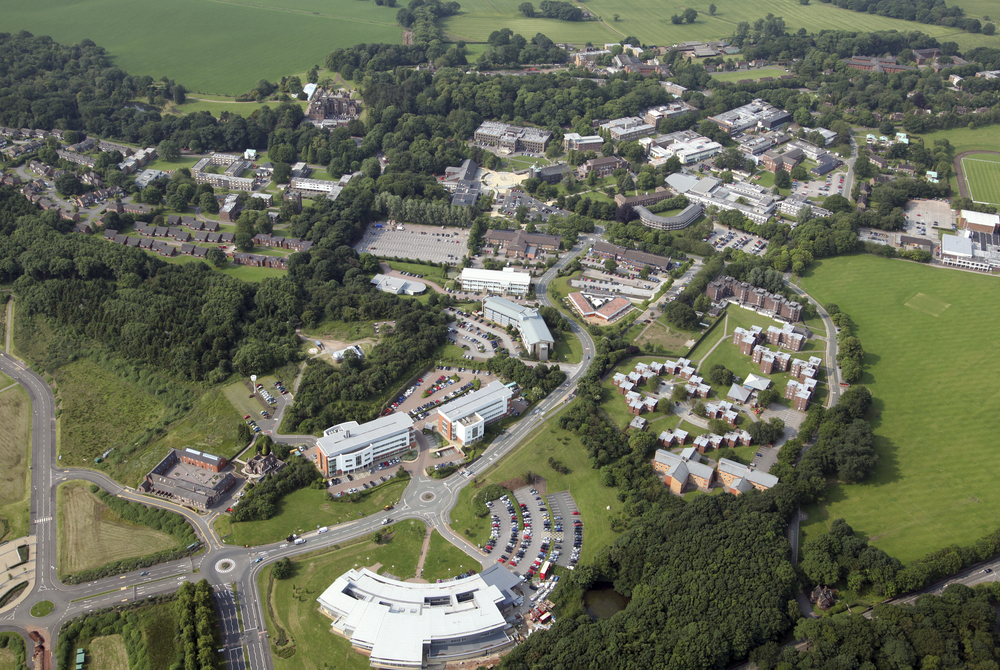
[56,481,176,575]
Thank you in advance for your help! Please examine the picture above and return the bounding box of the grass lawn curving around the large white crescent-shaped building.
[257,520,468,670]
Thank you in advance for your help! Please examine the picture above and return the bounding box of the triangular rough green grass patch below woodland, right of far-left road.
[56,359,164,467]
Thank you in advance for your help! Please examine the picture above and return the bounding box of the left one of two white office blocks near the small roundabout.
[316,413,416,477]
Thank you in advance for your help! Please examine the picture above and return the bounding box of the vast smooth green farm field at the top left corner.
[0,0,402,96]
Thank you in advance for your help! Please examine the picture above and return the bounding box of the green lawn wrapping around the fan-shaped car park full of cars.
[450,402,622,563]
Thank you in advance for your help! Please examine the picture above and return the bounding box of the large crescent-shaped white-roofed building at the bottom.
[317,565,524,669]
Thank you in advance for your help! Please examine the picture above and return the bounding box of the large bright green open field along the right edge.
[801,256,1000,562]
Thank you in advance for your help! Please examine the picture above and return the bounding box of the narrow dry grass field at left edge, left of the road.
[0,382,31,540]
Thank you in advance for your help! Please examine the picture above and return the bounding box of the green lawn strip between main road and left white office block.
[216,484,412,544]
